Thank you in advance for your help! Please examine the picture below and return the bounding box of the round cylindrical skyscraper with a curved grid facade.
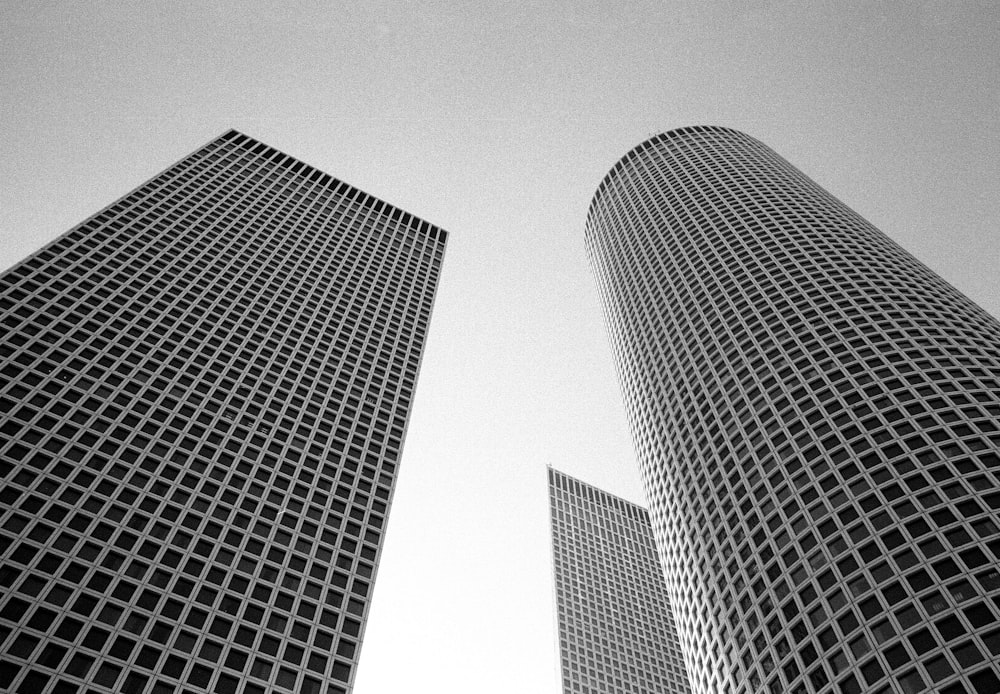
[586,127,1000,694]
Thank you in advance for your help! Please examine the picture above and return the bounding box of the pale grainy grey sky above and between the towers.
[0,0,1000,694]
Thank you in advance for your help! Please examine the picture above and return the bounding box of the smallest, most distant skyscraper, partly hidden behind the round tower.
[549,468,690,694]
